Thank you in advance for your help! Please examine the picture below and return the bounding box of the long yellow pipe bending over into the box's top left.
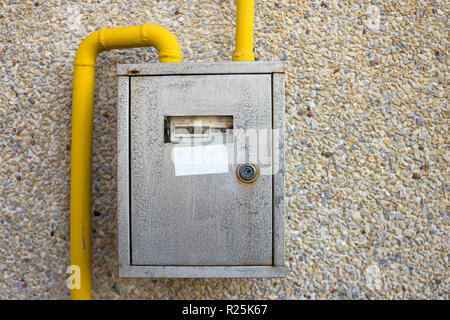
[70,24,182,299]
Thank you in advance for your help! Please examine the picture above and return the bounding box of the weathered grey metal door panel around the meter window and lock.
[130,74,273,266]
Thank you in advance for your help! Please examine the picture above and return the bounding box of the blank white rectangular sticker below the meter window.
[172,144,228,176]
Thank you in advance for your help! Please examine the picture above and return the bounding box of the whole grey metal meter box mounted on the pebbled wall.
[118,61,285,278]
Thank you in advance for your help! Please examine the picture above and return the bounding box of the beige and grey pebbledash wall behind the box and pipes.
[0,0,450,299]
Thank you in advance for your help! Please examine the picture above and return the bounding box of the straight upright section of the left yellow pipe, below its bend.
[70,66,95,300]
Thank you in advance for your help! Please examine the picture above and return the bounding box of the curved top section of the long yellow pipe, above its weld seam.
[74,24,182,67]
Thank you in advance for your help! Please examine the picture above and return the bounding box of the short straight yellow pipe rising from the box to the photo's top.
[232,0,255,61]
